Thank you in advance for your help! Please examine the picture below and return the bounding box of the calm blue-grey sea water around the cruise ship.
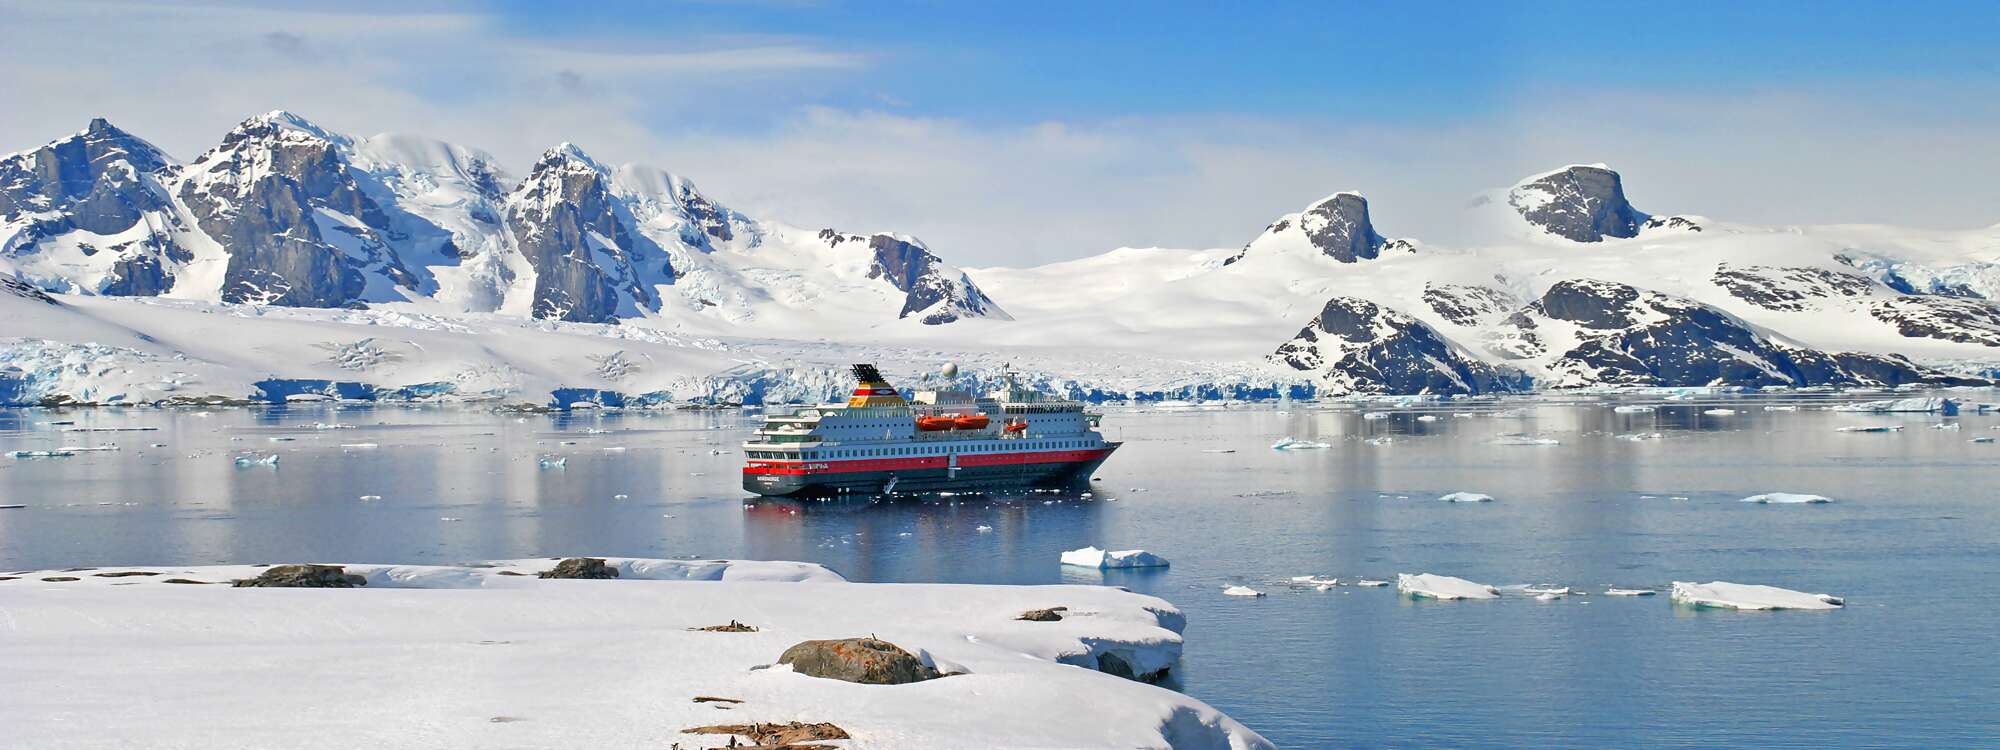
[0,400,2000,748]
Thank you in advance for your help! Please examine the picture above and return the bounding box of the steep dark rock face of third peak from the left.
[508,148,674,322]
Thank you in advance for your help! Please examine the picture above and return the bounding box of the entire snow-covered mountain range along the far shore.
[0,112,2000,412]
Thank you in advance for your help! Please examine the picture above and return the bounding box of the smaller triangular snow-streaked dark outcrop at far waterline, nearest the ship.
[1270,296,1528,394]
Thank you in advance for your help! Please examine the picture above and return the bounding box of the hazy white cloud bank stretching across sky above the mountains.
[0,4,2000,266]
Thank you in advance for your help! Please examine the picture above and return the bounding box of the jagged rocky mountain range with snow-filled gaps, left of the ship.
[0,112,1006,336]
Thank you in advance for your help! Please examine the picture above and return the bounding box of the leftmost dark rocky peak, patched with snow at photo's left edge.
[0,118,192,296]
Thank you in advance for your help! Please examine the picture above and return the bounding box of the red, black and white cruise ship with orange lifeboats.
[742,364,1120,496]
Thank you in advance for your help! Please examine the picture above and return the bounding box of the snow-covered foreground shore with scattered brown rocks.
[0,560,1270,750]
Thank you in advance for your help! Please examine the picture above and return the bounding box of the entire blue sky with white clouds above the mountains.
[0,0,2000,266]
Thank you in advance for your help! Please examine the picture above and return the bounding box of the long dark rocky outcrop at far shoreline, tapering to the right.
[1496,278,1956,386]
